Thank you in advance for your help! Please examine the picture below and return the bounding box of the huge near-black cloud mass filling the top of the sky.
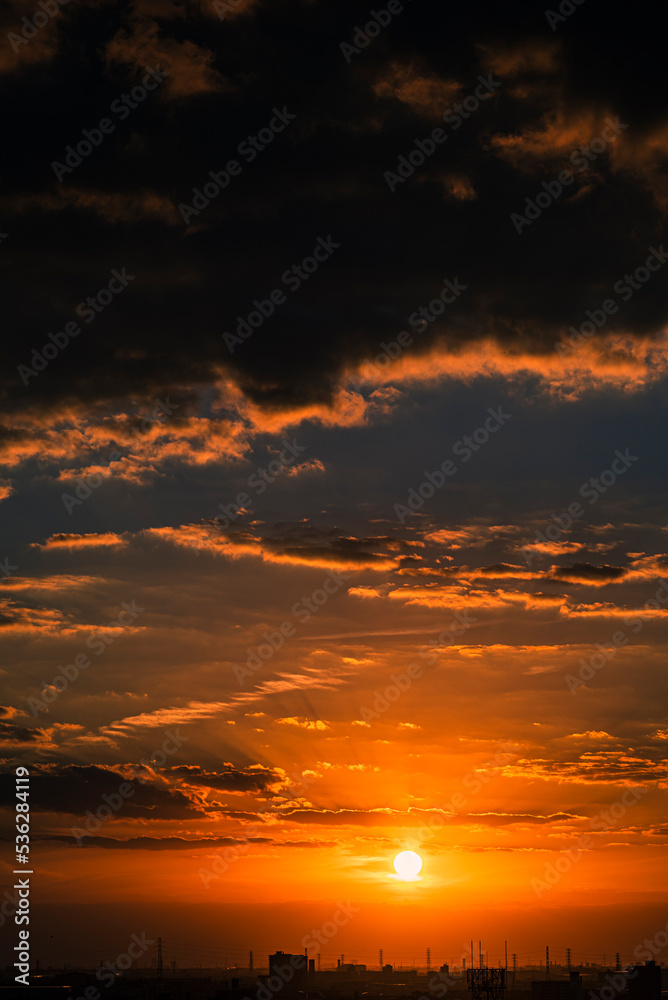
[2,0,668,422]
